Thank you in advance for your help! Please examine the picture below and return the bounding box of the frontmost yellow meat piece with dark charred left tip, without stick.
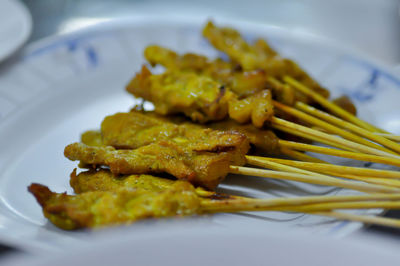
[28,181,200,230]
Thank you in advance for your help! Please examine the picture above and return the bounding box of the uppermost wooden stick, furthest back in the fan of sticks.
[283,76,387,133]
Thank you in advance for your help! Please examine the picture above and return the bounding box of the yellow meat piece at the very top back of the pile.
[203,22,329,102]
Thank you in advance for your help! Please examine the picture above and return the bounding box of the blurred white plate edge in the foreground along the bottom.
[1,222,400,266]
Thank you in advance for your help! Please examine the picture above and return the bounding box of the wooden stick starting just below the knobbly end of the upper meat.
[270,117,400,158]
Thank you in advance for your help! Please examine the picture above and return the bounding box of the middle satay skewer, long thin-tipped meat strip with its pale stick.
[65,140,400,193]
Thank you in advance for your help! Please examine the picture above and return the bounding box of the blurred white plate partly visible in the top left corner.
[0,0,32,61]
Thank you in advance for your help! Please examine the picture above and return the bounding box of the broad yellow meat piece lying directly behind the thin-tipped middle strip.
[101,110,249,165]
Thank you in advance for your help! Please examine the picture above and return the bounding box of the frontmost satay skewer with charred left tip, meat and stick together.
[29,181,400,230]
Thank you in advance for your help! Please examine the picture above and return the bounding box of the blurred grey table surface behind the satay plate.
[0,0,400,255]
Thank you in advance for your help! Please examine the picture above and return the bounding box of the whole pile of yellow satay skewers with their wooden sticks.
[29,22,400,229]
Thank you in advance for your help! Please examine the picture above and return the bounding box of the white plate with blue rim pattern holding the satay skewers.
[0,17,400,254]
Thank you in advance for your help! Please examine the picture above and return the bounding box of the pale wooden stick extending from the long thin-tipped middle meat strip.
[230,166,400,193]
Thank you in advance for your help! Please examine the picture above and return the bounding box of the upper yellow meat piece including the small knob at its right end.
[126,67,273,127]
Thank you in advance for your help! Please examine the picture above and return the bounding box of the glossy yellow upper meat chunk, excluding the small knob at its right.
[126,66,235,123]
